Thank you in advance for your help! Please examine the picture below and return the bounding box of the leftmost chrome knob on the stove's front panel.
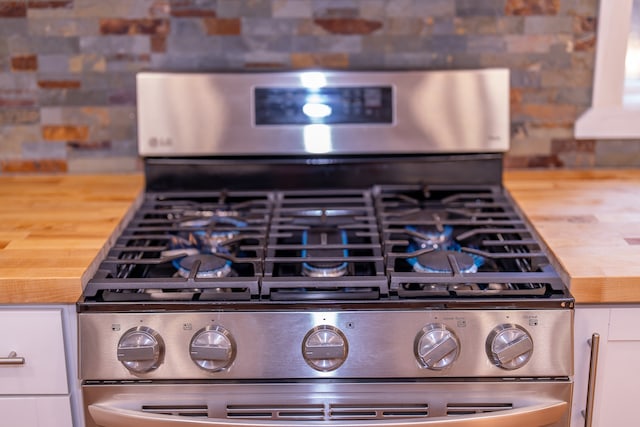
[117,326,164,373]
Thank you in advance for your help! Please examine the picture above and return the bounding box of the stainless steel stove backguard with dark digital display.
[137,69,509,157]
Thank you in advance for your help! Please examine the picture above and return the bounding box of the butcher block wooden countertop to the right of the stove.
[504,169,640,303]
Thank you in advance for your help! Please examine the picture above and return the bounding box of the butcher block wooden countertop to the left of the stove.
[0,175,144,304]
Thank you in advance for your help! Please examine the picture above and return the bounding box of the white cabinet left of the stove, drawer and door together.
[0,307,73,427]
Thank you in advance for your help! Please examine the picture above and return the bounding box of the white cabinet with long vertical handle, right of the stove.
[571,306,640,427]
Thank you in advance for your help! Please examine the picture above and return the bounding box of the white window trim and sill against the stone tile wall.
[574,0,640,139]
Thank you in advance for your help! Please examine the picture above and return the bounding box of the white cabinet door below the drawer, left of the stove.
[0,396,73,427]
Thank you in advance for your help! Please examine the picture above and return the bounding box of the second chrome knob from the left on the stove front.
[189,325,236,372]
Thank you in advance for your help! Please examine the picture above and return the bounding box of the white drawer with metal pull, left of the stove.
[0,309,68,395]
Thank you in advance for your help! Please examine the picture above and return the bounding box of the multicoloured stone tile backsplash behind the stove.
[0,0,640,173]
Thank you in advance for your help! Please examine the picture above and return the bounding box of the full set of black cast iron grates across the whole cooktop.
[84,185,564,302]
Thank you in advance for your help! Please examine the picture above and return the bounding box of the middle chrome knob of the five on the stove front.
[302,325,348,372]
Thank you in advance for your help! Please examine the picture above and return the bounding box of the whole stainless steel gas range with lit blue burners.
[78,69,573,427]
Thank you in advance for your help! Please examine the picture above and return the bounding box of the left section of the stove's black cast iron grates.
[85,192,272,301]
